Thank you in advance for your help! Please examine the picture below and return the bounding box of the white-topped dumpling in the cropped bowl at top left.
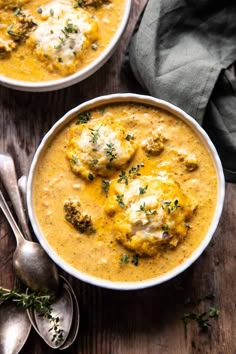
[30,1,98,75]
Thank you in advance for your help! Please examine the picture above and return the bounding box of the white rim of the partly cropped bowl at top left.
[0,0,132,92]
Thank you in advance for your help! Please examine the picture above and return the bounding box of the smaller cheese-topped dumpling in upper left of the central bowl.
[67,116,137,180]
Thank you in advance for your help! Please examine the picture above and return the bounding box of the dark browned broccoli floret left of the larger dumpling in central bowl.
[64,200,95,234]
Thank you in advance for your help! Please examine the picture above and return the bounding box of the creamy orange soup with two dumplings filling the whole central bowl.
[33,104,217,281]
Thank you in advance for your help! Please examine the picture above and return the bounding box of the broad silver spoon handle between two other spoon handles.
[0,153,32,241]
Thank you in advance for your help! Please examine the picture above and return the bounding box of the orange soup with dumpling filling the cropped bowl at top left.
[0,0,125,82]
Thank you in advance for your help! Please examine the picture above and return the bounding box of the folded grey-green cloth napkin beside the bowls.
[129,0,236,182]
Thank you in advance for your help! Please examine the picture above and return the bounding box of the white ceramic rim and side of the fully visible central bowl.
[27,94,225,290]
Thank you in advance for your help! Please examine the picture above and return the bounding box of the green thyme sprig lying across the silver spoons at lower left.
[0,287,64,345]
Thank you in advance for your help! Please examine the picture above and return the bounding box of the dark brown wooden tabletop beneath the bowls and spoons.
[0,0,236,354]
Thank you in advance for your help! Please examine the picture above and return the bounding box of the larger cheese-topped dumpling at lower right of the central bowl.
[106,174,196,256]
